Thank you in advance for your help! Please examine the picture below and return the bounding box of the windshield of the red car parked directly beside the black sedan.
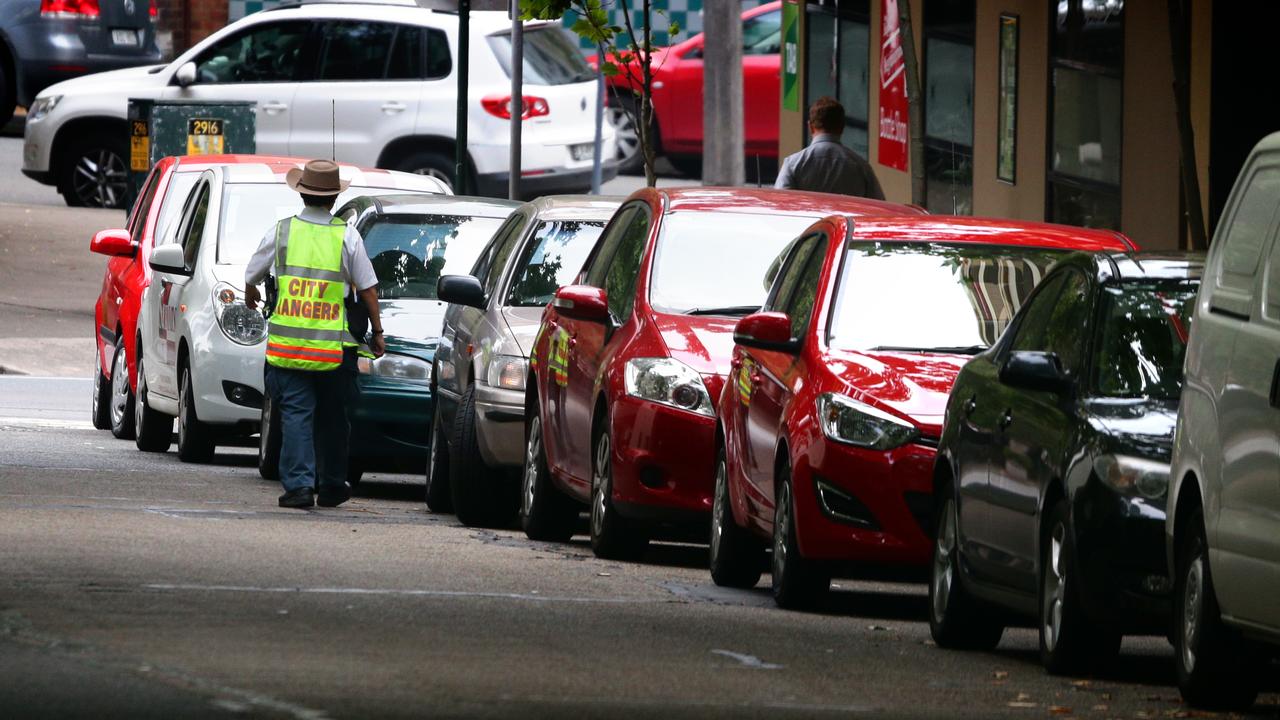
[828,241,1064,354]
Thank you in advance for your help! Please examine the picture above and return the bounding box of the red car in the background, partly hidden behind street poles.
[593,3,782,174]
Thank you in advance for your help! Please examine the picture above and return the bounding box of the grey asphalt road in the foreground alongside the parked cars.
[0,377,1280,720]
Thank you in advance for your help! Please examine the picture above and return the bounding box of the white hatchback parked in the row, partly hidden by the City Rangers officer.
[134,158,449,462]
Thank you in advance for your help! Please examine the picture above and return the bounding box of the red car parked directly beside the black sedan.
[710,215,1133,607]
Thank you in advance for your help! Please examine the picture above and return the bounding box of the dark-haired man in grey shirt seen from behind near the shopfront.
[773,97,884,200]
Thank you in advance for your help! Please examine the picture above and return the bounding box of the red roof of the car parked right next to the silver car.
[650,187,924,219]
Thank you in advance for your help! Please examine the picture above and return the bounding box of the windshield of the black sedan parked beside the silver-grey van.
[1093,282,1196,400]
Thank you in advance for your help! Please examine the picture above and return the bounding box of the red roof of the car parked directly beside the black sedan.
[852,215,1134,251]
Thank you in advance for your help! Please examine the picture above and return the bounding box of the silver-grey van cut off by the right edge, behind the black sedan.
[1165,128,1280,708]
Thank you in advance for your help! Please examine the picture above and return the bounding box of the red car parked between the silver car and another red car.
[521,188,919,559]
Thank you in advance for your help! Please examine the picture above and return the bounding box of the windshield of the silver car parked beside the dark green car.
[507,220,604,307]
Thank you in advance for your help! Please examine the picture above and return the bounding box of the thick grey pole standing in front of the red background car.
[703,0,747,186]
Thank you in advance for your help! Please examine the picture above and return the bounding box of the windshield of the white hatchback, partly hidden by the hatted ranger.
[218,182,416,265]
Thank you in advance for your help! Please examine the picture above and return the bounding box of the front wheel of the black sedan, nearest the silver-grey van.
[1039,500,1121,675]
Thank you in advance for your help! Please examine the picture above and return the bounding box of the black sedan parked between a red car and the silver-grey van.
[929,254,1203,674]
